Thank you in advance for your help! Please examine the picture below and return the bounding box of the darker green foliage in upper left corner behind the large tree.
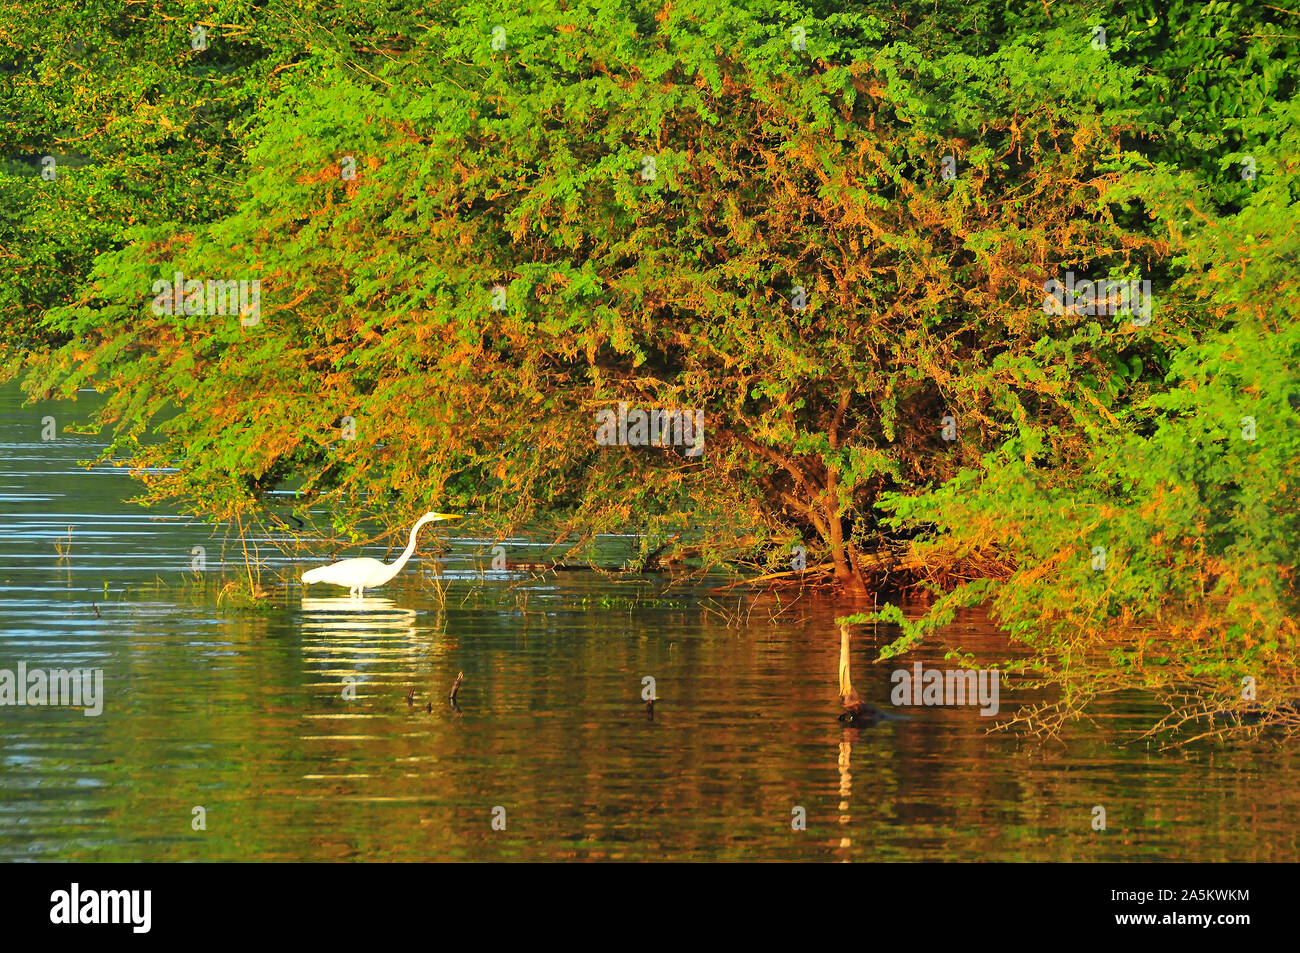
[0,0,444,364]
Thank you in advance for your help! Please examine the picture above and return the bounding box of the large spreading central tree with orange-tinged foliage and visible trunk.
[15,3,1151,564]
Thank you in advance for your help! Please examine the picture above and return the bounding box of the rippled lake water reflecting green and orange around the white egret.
[0,385,1300,861]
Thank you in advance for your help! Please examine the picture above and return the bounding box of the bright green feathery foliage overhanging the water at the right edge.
[884,103,1300,701]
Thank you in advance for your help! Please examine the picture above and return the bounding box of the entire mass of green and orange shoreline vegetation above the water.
[0,0,1300,733]
